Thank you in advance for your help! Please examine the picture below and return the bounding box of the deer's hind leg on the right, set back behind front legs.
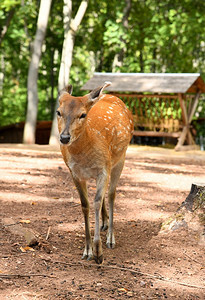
[106,155,125,248]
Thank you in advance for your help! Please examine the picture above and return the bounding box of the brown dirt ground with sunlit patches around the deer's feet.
[0,144,205,300]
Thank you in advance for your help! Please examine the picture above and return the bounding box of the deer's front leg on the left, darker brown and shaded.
[73,178,93,260]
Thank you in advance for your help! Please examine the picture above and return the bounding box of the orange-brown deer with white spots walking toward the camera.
[56,82,134,264]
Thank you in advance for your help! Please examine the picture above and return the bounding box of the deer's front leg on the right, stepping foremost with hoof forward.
[93,172,108,264]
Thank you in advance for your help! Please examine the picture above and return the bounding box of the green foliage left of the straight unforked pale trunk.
[0,1,37,126]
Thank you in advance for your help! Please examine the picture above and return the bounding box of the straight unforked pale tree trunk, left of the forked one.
[23,0,52,144]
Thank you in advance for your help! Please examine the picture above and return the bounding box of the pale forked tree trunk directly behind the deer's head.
[49,0,88,145]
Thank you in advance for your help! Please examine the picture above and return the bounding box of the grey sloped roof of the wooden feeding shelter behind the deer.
[82,73,205,93]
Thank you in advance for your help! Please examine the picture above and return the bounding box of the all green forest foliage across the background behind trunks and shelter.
[0,0,205,141]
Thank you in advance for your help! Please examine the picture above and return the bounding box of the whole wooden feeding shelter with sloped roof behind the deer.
[82,73,205,150]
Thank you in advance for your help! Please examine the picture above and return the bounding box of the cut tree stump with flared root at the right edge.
[161,183,205,244]
